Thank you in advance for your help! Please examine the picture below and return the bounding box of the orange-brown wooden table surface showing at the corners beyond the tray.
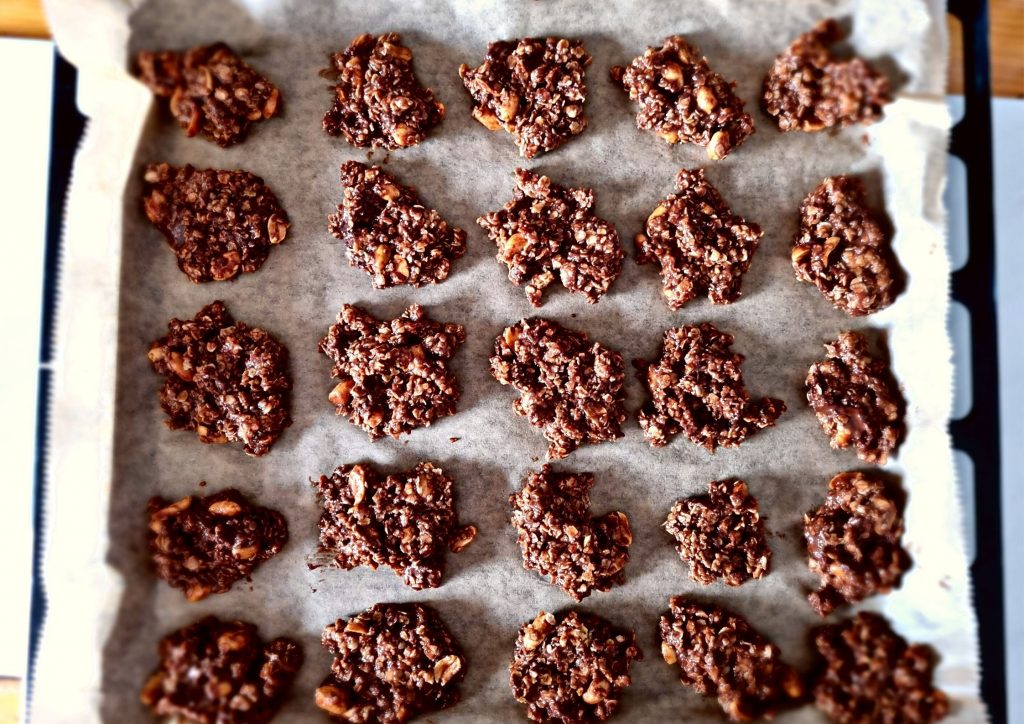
[0,0,1024,724]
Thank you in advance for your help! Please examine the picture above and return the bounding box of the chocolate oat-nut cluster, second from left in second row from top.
[328,161,466,289]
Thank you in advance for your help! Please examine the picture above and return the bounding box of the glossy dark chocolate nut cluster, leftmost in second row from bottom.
[148,487,288,601]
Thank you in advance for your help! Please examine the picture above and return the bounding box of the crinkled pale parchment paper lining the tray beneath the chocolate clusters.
[34,0,985,722]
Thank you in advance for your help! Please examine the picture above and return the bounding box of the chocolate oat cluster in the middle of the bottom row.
[509,611,643,724]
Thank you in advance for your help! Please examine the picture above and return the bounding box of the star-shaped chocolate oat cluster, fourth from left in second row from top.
[636,169,764,309]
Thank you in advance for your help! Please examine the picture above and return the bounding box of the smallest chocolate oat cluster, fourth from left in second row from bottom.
[665,480,771,586]
